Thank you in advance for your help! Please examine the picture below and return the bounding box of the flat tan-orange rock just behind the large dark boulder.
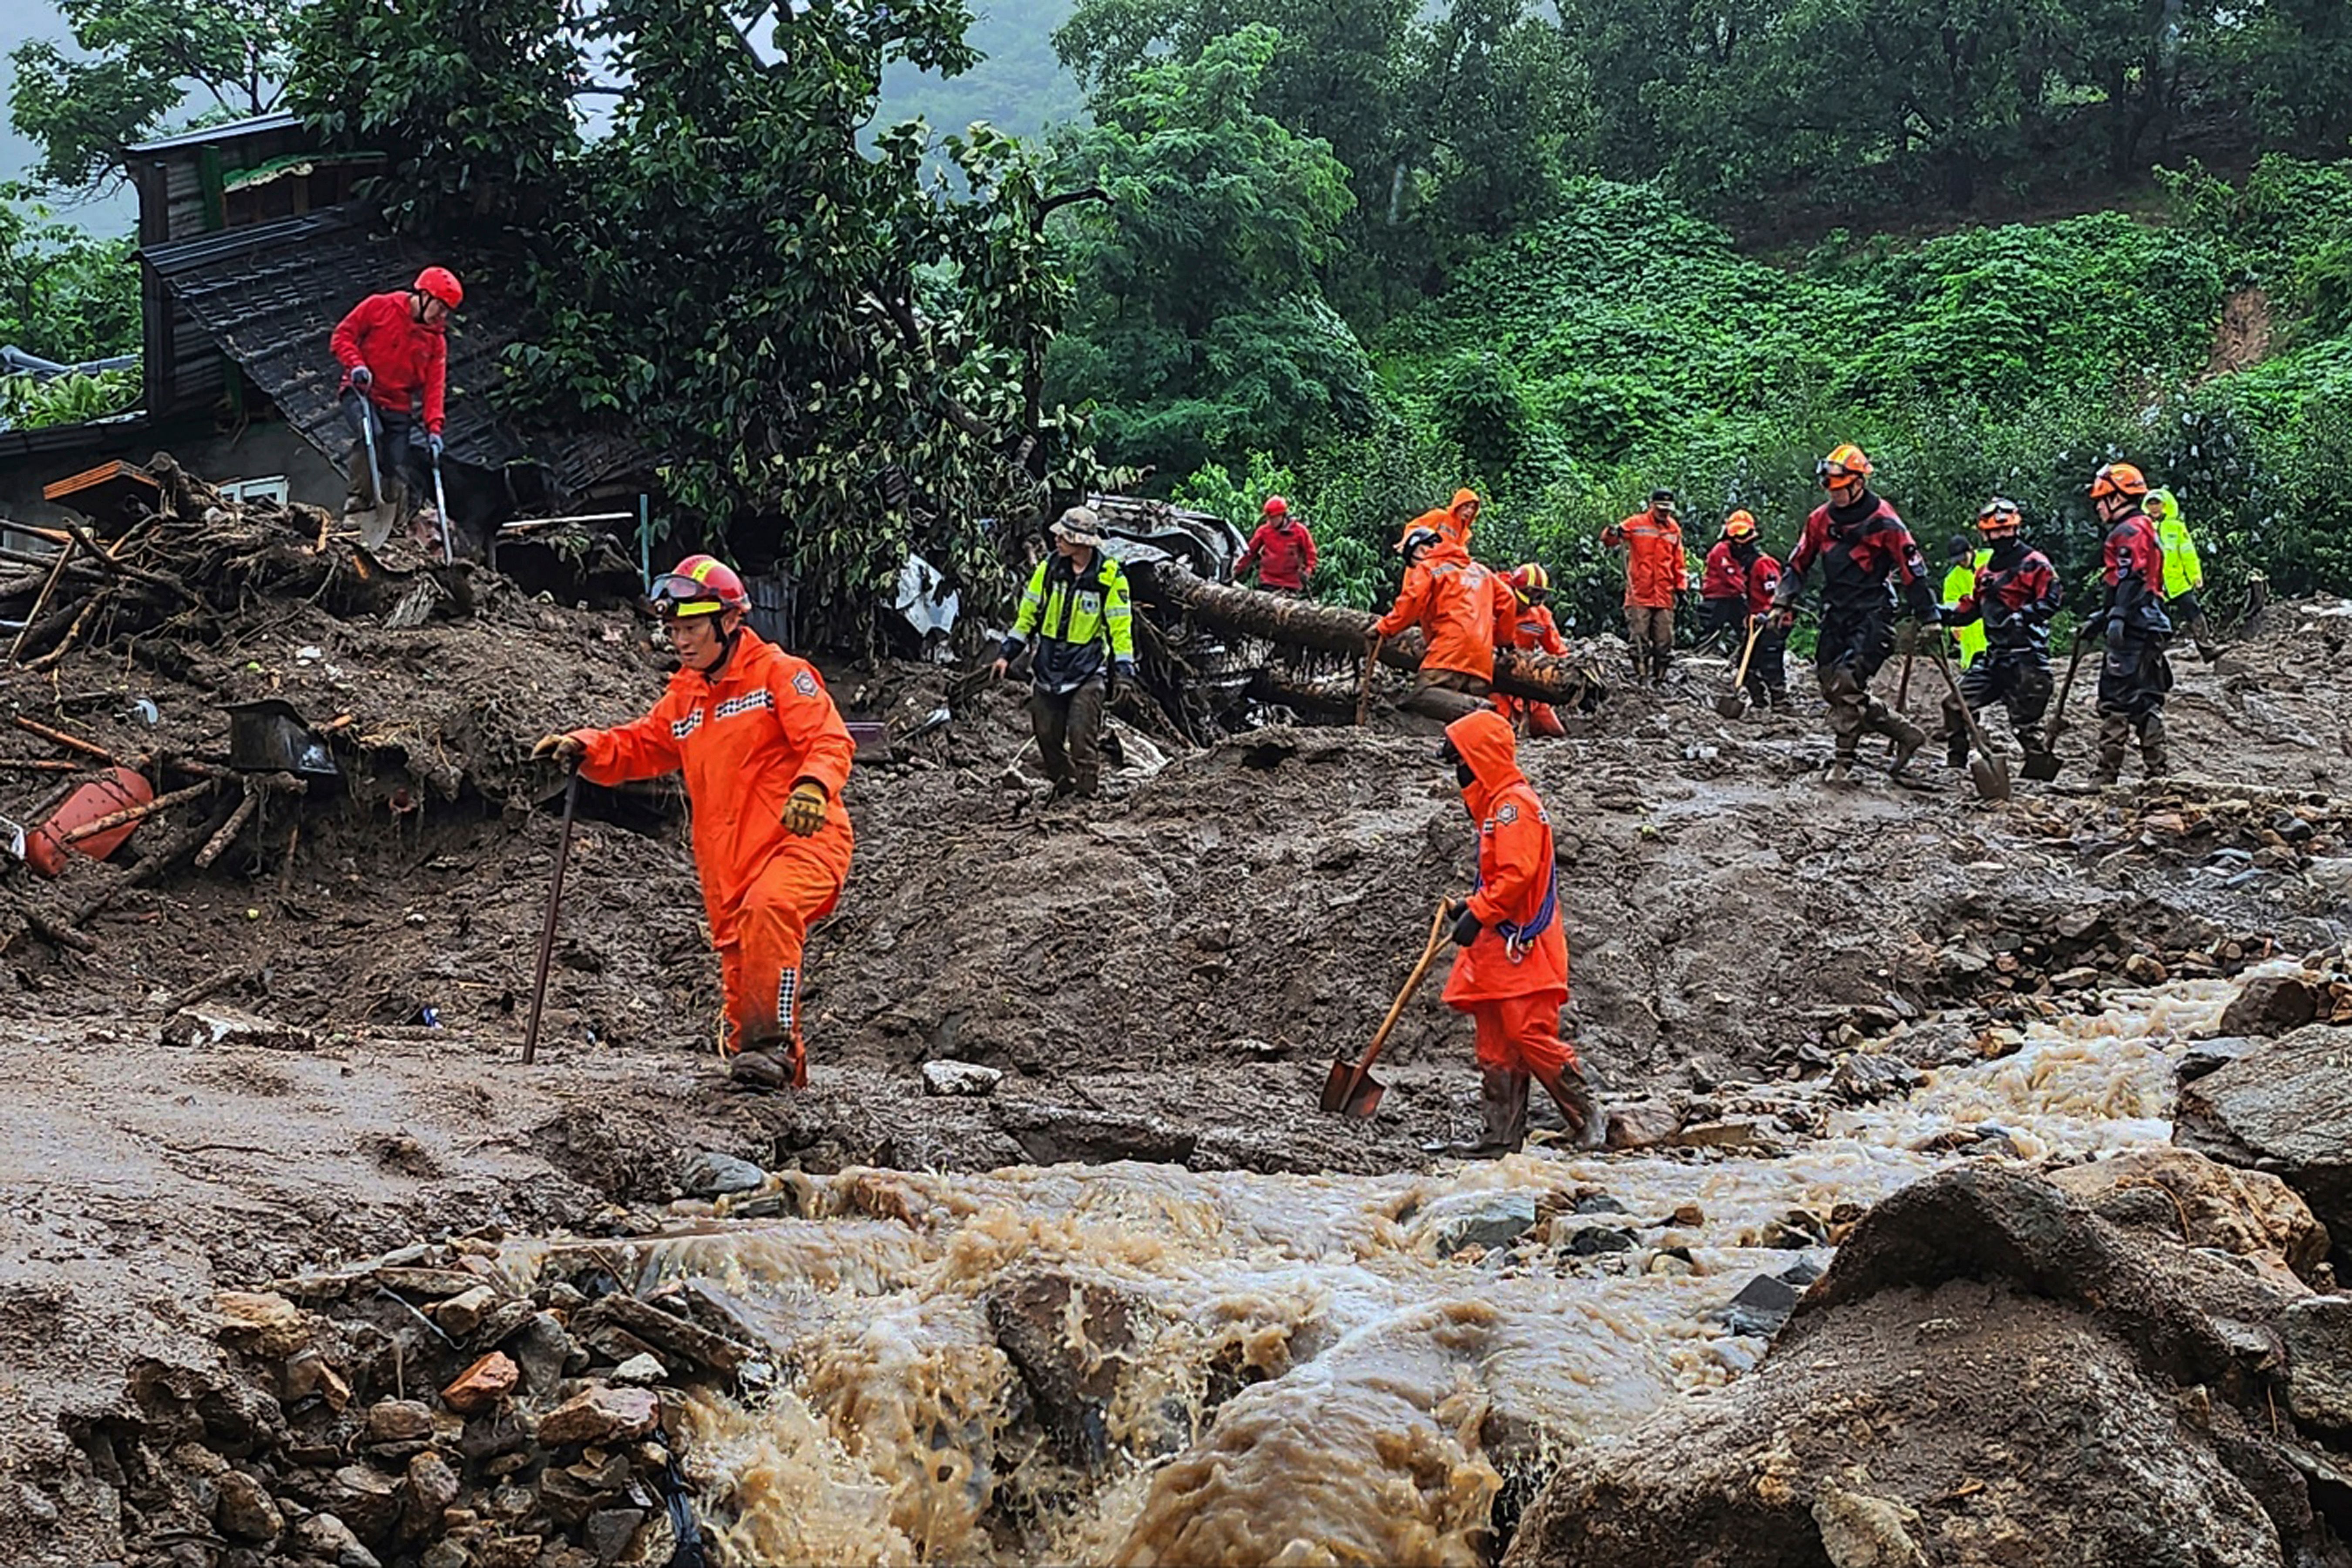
[2048,1149,2328,1277]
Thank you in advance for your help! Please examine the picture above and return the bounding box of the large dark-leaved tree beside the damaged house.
[296,0,1103,635]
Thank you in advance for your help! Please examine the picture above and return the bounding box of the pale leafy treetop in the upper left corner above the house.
[10,0,296,190]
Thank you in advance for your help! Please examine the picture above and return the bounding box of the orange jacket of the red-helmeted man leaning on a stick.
[571,628,856,947]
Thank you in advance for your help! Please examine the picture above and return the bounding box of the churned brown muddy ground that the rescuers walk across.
[0,496,2352,1563]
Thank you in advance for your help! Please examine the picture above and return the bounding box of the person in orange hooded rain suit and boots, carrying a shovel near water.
[1437,710,1609,1159]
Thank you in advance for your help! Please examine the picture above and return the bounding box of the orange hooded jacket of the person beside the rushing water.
[1446,708,1569,1006]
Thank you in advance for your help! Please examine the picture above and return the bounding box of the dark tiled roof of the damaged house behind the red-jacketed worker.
[141,205,652,501]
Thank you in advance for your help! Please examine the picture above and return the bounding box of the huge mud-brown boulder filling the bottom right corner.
[1505,1168,2324,1568]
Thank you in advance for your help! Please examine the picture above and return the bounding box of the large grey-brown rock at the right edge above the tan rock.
[2173,1025,2352,1246]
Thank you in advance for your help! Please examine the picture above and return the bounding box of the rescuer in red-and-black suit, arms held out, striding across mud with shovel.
[1774,444,1943,783]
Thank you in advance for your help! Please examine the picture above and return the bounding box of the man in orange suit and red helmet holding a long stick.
[531,555,856,1091]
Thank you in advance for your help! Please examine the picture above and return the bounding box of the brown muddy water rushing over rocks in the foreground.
[513,980,2234,1563]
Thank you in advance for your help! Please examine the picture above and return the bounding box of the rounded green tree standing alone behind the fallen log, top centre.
[1047,26,1371,475]
